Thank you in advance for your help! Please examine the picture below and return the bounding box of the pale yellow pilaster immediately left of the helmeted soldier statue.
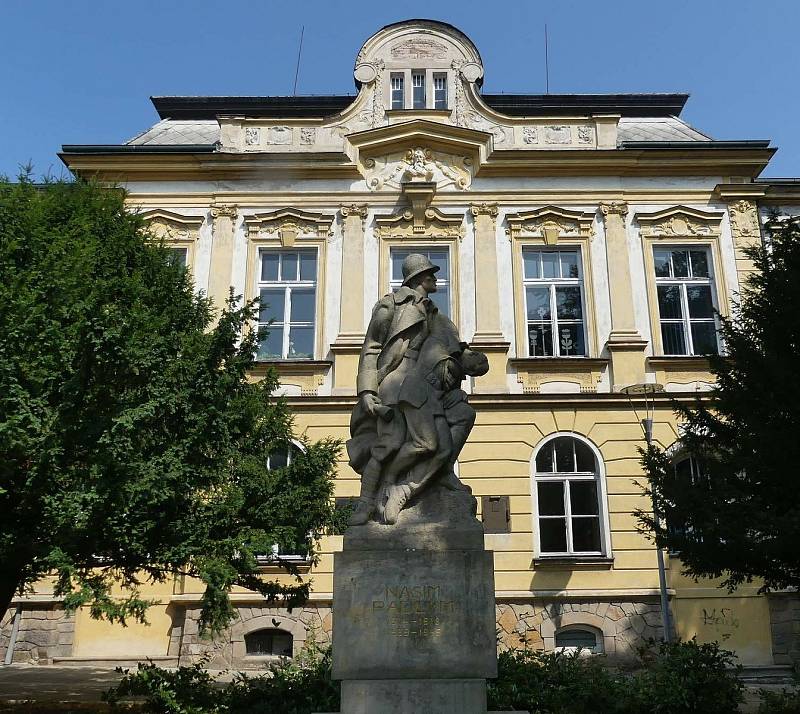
[331,203,368,394]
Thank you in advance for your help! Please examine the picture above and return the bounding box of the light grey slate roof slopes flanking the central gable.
[125,117,711,146]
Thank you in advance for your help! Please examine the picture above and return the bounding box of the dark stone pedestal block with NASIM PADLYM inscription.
[333,550,496,679]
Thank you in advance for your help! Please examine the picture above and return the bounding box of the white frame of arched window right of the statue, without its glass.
[531,431,612,559]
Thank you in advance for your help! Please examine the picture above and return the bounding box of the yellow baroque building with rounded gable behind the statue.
[6,20,800,668]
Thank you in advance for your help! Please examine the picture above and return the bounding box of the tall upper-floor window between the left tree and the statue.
[257,249,317,360]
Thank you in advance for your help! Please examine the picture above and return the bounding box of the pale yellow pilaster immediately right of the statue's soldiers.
[470,203,510,393]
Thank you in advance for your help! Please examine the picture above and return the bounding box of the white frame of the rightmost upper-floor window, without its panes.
[653,243,722,357]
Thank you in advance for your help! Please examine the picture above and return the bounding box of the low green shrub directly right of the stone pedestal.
[488,650,626,714]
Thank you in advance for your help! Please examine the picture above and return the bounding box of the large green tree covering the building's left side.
[0,177,339,631]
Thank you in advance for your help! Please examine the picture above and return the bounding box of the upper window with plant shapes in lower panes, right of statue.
[522,248,586,357]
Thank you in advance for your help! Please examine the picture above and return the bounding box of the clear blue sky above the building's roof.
[0,0,800,176]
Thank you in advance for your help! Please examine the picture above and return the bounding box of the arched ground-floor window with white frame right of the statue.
[534,436,604,556]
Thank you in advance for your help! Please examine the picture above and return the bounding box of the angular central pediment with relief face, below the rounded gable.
[345,119,492,191]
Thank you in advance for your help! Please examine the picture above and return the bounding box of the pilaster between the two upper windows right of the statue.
[600,201,647,391]
